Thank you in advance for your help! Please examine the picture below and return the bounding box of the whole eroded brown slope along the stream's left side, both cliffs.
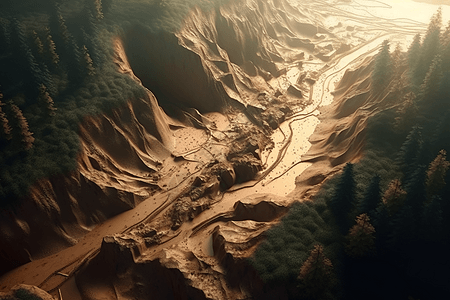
[0,0,348,273]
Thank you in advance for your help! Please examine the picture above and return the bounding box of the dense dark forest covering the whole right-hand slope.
[251,10,450,300]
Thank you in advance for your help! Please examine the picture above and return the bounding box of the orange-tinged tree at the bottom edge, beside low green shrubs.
[298,245,333,299]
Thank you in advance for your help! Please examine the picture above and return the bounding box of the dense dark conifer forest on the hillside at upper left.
[0,0,143,207]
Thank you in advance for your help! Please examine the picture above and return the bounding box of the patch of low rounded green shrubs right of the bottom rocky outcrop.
[250,202,341,296]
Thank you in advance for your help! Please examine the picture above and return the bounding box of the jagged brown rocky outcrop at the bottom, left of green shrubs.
[76,194,288,300]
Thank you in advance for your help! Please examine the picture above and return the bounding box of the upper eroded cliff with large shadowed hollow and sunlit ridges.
[124,0,343,116]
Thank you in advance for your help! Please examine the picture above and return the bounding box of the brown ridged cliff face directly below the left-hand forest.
[0,40,173,272]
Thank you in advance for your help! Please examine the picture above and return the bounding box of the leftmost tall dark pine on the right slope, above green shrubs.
[329,163,356,234]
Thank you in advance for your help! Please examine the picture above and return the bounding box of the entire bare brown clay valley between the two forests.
[0,0,445,300]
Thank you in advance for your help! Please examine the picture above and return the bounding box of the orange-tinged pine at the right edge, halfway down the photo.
[426,150,450,200]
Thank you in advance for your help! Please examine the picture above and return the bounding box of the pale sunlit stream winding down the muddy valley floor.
[2,0,450,291]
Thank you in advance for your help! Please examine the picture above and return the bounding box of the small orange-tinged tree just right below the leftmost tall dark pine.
[345,214,375,258]
